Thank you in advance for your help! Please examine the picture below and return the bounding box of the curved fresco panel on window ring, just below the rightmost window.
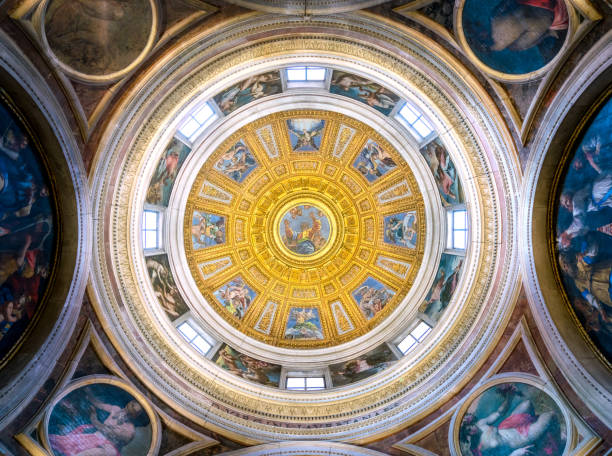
[419,253,463,321]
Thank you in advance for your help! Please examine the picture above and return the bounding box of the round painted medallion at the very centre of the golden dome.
[278,204,330,255]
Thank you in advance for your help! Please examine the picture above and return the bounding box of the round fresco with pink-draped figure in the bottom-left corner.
[47,383,153,456]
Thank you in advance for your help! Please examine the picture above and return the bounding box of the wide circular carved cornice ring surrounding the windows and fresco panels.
[92,15,518,444]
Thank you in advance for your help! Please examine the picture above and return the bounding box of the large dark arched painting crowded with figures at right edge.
[556,99,612,362]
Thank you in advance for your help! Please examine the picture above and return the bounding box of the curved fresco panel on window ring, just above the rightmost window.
[421,138,465,205]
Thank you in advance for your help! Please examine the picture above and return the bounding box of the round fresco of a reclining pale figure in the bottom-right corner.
[459,382,566,456]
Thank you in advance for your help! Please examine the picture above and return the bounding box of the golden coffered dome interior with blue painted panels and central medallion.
[183,110,426,348]
